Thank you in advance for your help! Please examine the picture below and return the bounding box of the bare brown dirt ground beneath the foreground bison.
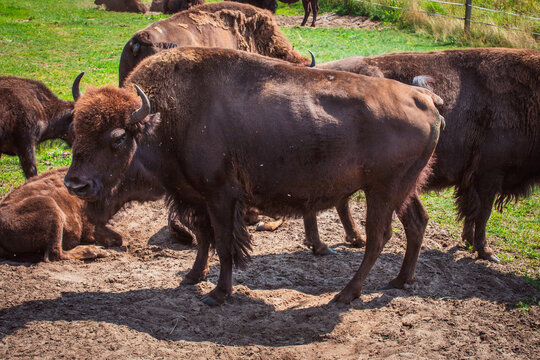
[0,198,540,359]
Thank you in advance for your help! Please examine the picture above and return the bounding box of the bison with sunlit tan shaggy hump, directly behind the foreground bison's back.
[119,1,309,86]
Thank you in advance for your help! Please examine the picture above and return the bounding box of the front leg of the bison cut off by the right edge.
[474,187,500,262]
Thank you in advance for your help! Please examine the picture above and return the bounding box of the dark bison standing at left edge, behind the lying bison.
[0,76,77,178]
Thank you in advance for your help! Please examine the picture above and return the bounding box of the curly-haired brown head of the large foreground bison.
[64,76,159,201]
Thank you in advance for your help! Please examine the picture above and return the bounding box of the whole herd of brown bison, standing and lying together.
[0,0,540,305]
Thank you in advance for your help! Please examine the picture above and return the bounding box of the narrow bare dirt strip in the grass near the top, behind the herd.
[275,14,382,29]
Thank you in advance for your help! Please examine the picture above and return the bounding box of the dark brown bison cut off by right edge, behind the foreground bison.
[319,48,540,261]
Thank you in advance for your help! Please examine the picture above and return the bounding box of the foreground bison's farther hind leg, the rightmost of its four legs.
[390,194,429,289]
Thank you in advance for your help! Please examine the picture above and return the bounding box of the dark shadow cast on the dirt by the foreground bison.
[0,244,535,346]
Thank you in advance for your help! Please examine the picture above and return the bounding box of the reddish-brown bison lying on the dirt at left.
[0,163,191,261]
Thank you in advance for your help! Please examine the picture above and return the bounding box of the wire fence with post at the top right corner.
[345,0,540,37]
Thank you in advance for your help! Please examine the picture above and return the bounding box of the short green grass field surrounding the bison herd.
[0,0,540,283]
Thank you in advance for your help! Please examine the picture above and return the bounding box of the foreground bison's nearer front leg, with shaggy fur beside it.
[202,192,243,306]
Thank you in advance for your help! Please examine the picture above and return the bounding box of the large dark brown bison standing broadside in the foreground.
[65,47,442,305]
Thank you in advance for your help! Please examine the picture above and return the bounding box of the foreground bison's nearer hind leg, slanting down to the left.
[333,192,393,304]
